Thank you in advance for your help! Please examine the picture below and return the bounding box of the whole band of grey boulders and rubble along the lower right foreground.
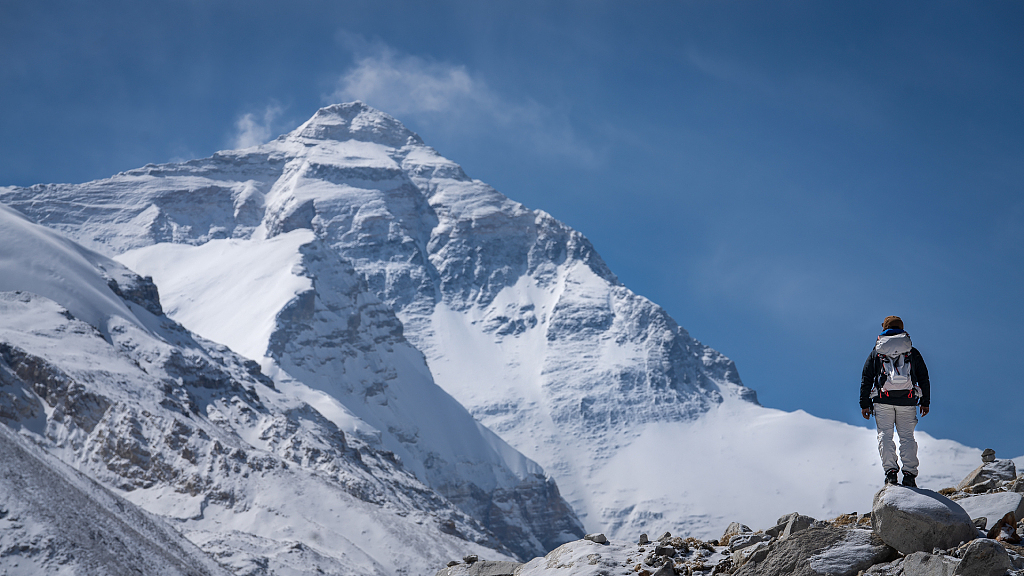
[437,449,1024,576]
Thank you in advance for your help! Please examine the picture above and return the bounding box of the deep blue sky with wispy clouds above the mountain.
[0,0,1024,455]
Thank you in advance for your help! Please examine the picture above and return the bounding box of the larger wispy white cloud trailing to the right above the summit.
[325,35,597,165]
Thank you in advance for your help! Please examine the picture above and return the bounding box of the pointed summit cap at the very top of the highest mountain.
[286,100,423,148]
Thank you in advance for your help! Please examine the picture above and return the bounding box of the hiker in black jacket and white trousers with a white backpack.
[860,316,932,487]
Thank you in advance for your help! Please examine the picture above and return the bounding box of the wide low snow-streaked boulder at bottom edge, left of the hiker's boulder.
[734,526,897,576]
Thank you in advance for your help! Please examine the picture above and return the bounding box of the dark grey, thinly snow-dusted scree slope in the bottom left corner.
[0,425,230,576]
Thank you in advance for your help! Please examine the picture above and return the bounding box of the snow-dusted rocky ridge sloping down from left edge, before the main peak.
[0,206,520,575]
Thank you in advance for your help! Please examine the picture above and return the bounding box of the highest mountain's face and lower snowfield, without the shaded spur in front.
[0,102,991,538]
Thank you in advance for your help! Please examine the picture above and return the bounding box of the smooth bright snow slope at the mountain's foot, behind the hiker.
[592,393,981,539]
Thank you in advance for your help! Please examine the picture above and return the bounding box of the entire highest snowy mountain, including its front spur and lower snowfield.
[0,102,976,541]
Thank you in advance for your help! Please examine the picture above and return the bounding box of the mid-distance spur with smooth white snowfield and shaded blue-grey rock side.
[119,230,583,558]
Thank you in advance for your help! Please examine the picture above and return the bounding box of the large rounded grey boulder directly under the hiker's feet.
[871,486,978,554]
